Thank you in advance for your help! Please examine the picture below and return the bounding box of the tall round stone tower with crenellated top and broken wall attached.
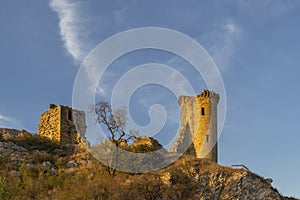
[171,90,219,162]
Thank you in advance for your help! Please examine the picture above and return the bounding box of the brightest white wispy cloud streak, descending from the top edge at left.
[50,0,87,62]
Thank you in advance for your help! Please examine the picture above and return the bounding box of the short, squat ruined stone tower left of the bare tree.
[38,104,86,144]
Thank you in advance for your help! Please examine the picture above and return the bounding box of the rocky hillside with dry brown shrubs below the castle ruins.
[0,129,293,200]
